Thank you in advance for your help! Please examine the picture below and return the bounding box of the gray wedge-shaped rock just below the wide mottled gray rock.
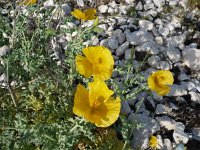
[135,41,159,54]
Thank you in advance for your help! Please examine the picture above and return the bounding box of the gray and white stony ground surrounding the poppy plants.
[0,0,200,150]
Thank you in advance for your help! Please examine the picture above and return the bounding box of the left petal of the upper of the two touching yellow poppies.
[76,55,92,78]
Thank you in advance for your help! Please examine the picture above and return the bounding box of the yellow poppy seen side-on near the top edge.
[71,8,96,20]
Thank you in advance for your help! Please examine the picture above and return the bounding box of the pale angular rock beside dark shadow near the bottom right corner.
[173,129,189,144]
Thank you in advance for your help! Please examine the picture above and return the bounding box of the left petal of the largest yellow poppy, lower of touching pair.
[73,84,90,116]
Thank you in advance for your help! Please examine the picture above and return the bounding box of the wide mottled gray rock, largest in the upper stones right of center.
[126,30,154,45]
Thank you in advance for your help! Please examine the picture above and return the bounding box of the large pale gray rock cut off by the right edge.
[182,48,200,71]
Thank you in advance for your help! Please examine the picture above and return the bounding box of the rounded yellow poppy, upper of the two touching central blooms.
[76,46,114,80]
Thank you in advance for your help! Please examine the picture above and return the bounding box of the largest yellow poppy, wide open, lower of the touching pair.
[73,79,121,127]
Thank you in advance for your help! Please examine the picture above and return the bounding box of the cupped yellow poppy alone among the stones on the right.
[148,70,174,96]
